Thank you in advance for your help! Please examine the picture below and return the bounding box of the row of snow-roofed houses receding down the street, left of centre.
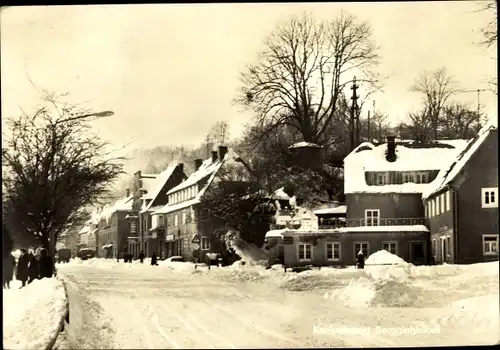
[74,146,258,260]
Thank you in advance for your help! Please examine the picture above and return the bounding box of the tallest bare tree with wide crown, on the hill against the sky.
[236,12,379,144]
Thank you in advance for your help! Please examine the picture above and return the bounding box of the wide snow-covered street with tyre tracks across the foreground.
[52,259,499,349]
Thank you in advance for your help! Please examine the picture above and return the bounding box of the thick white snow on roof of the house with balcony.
[344,140,468,194]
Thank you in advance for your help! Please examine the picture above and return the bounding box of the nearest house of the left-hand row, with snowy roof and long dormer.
[151,146,254,261]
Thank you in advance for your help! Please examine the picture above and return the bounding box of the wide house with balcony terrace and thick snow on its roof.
[266,137,467,266]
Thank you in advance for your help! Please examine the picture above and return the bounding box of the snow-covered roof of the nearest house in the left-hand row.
[153,149,245,214]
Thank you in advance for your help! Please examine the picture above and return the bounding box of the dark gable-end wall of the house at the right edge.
[456,130,499,263]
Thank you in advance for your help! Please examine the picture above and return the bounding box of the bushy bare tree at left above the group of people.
[2,94,122,258]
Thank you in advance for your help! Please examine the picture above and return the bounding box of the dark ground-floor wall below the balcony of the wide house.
[283,232,429,267]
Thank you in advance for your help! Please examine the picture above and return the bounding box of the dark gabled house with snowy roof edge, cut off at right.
[422,124,499,264]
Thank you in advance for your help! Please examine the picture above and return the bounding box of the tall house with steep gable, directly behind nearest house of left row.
[127,164,186,257]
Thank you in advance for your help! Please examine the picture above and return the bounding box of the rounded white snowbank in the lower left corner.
[3,278,67,349]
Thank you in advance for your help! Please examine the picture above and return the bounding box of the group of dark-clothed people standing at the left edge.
[3,249,56,289]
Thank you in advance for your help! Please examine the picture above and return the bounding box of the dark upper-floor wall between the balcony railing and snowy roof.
[346,193,425,221]
